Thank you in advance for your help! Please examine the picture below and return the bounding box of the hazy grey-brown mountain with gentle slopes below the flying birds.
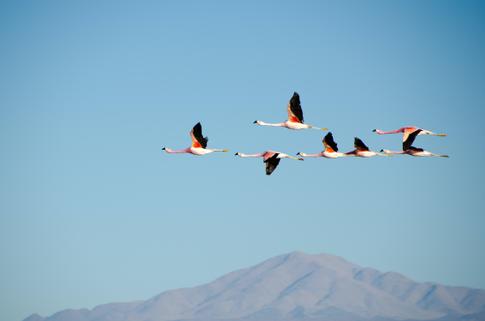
[24,252,485,321]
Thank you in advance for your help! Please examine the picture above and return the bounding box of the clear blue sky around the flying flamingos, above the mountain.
[0,1,485,321]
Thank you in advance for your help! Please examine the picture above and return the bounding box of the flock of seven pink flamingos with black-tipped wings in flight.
[162,92,448,175]
